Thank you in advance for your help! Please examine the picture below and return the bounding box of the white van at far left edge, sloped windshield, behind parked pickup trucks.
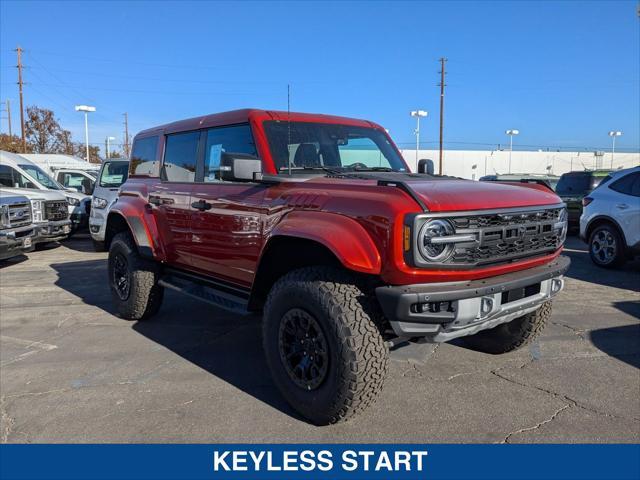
[0,150,91,233]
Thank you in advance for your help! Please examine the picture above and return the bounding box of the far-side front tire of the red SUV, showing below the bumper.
[464,301,551,355]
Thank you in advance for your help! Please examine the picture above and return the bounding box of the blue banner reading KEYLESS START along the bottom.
[0,444,640,480]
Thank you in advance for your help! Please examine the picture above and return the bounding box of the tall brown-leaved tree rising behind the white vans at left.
[25,105,71,153]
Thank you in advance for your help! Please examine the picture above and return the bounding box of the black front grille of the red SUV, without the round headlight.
[413,206,566,268]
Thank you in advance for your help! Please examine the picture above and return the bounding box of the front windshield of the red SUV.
[264,121,407,172]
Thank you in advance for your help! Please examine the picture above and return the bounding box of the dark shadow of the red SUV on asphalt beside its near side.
[52,259,302,420]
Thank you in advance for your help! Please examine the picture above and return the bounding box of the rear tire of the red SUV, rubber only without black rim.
[108,232,164,320]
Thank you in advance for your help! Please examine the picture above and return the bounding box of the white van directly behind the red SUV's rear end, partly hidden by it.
[89,159,129,252]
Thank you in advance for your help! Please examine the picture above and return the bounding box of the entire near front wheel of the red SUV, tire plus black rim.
[263,267,388,425]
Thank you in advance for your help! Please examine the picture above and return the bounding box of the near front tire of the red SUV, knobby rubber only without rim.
[262,267,389,425]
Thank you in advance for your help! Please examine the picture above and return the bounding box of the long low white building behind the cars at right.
[400,149,640,180]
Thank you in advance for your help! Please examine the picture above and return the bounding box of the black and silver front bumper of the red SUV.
[376,256,571,342]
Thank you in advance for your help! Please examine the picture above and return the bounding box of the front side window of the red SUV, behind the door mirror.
[204,125,257,182]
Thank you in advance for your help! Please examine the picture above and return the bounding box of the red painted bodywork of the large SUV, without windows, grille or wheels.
[111,110,560,288]
